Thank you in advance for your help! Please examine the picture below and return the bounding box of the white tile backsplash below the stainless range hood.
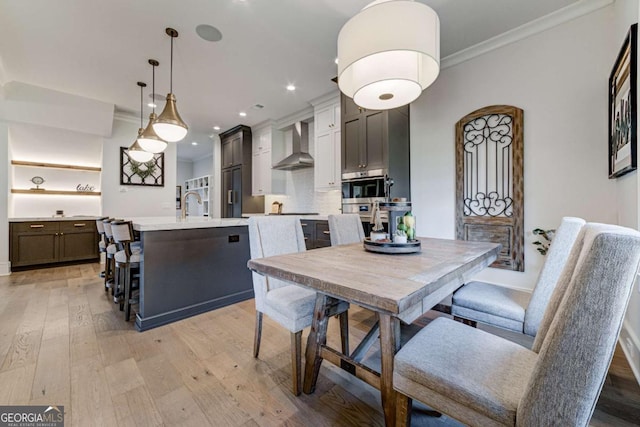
[264,168,342,215]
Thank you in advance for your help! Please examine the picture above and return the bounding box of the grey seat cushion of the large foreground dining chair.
[393,318,538,425]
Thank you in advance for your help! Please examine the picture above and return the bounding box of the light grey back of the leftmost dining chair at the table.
[249,215,307,311]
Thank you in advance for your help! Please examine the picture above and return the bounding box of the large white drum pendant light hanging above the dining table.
[338,0,440,110]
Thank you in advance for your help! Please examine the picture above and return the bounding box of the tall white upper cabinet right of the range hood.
[313,96,341,191]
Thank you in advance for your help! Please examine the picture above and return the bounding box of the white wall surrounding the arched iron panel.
[411,7,617,288]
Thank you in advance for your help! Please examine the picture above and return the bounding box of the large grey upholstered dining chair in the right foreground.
[393,224,640,426]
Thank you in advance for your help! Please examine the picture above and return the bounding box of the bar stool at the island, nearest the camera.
[111,221,142,322]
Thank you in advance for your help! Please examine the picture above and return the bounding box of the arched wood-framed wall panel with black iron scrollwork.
[456,105,524,271]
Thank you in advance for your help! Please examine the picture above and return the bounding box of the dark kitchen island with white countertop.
[131,217,253,331]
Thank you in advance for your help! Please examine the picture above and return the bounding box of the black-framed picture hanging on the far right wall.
[609,24,638,179]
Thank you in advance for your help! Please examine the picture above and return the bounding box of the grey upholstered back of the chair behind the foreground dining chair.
[524,217,585,337]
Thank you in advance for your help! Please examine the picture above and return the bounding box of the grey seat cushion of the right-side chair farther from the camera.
[451,282,531,333]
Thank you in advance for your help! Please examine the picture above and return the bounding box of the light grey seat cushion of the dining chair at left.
[265,285,316,330]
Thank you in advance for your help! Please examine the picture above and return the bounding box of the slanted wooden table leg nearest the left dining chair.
[302,293,329,394]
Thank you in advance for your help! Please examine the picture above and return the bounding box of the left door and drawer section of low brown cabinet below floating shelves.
[10,221,59,267]
